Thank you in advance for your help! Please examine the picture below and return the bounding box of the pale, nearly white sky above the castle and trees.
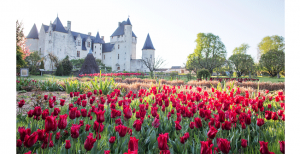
[16,0,285,68]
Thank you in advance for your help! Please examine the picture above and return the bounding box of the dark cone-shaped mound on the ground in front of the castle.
[79,49,100,74]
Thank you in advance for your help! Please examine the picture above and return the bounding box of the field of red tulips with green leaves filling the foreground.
[16,78,285,154]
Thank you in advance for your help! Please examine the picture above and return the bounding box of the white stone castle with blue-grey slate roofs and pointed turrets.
[26,17,155,72]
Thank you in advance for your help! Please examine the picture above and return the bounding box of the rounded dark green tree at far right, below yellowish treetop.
[259,50,285,78]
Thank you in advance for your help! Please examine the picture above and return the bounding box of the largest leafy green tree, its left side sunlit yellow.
[187,33,226,74]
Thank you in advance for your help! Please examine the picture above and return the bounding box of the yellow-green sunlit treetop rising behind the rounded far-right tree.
[258,35,285,56]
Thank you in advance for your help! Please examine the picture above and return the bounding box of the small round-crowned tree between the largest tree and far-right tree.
[229,53,254,77]
